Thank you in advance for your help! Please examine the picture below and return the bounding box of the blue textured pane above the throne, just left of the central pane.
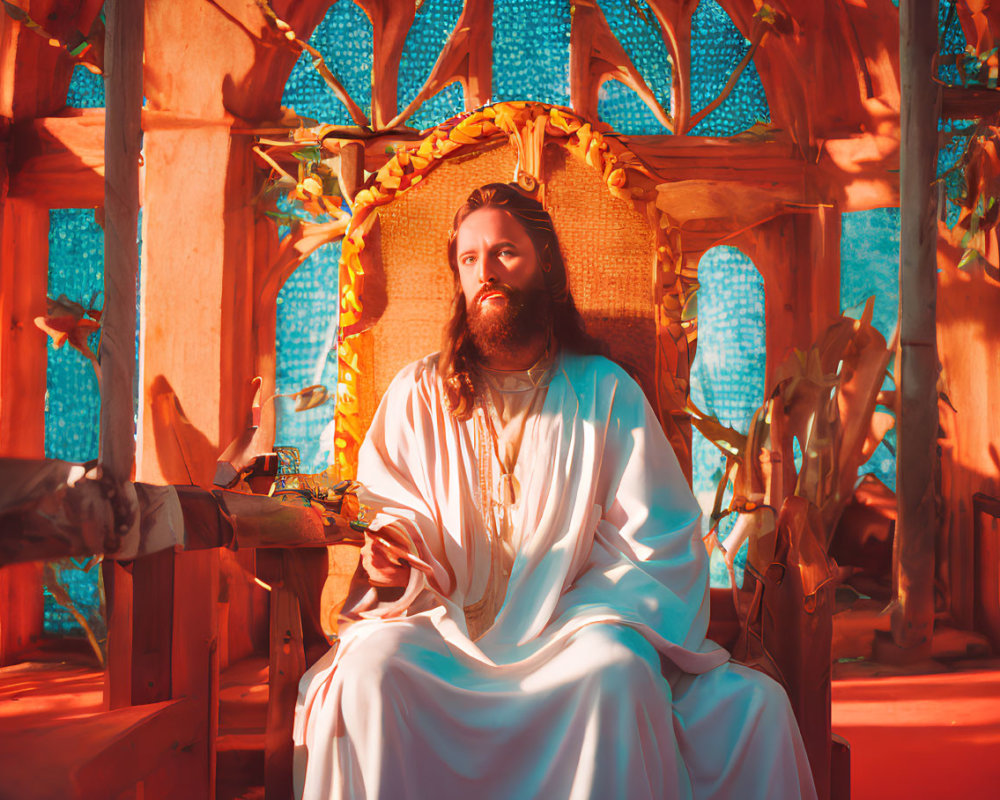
[397,0,465,130]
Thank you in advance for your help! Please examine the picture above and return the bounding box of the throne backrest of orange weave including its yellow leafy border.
[338,104,686,482]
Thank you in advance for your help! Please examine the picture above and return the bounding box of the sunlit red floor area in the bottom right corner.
[833,669,1000,800]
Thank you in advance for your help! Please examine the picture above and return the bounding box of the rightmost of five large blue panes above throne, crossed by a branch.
[691,0,771,136]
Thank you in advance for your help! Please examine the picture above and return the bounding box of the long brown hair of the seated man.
[438,183,601,419]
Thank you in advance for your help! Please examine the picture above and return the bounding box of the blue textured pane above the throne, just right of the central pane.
[598,0,671,135]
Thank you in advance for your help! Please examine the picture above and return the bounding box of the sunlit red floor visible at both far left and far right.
[0,661,1000,800]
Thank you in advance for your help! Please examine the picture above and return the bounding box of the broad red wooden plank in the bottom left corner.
[0,700,198,800]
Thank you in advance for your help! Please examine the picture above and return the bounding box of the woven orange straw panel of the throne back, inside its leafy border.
[361,144,656,429]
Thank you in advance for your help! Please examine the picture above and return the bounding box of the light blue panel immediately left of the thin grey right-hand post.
[840,208,899,489]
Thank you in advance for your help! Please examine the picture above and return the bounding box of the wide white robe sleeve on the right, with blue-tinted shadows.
[557,371,728,672]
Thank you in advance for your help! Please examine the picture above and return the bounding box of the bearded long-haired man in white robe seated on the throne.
[296,184,815,800]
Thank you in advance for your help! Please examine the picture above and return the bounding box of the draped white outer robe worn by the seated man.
[295,355,815,800]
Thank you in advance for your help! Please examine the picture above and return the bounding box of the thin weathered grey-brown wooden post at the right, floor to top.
[892,0,938,652]
